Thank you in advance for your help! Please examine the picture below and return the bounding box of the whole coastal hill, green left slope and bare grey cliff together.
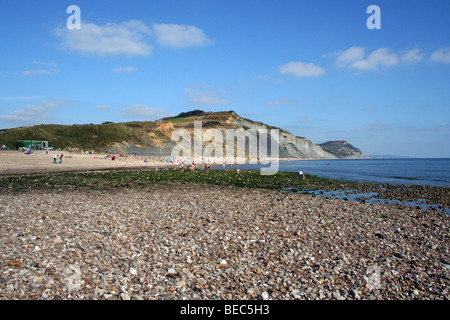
[0,110,362,159]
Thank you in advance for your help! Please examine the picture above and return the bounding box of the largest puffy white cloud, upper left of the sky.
[56,20,152,56]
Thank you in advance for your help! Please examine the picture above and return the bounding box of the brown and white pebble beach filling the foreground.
[0,183,450,300]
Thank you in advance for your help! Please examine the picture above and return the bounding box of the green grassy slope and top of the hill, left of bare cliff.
[0,110,246,150]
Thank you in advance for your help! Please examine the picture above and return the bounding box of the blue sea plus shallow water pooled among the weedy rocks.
[215,158,450,215]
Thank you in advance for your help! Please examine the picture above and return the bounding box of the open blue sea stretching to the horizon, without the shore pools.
[217,158,450,187]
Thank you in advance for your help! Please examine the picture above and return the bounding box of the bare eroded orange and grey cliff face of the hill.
[108,111,336,159]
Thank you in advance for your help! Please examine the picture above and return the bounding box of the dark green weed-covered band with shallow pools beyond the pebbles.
[0,167,450,215]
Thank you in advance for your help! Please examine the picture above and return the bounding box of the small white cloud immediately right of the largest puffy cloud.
[153,23,210,47]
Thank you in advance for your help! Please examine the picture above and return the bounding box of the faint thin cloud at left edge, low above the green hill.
[0,98,67,126]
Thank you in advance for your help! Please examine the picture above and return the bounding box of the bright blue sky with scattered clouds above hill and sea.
[0,0,450,157]
